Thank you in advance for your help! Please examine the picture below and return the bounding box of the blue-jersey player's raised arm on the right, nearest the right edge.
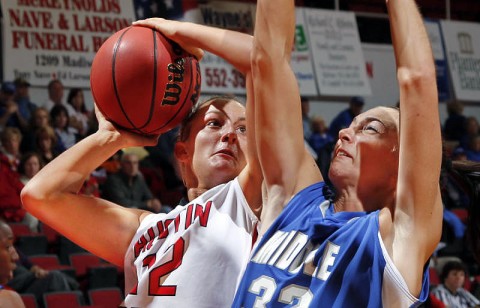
[381,0,442,294]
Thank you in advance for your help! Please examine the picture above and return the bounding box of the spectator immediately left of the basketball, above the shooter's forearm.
[67,88,92,137]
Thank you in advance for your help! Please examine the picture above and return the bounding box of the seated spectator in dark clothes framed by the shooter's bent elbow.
[102,153,162,213]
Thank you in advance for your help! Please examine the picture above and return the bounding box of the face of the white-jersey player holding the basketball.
[187,101,247,188]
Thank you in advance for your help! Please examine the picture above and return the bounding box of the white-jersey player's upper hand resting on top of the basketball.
[133,17,204,61]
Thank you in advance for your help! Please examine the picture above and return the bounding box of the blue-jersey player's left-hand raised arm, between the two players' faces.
[252,0,322,230]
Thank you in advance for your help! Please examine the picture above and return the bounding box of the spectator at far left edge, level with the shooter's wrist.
[0,127,22,171]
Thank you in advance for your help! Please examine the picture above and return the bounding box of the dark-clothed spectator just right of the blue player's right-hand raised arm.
[443,100,467,142]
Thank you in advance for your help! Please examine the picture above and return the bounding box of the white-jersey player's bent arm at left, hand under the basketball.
[21,107,157,266]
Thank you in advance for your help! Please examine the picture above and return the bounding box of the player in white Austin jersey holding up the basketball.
[22,20,262,307]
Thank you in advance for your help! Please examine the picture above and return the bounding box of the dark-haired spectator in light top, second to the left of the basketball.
[50,105,78,152]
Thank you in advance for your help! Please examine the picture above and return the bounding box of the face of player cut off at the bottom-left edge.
[0,226,18,284]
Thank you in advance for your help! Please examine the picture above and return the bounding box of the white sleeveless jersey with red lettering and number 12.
[124,178,258,307]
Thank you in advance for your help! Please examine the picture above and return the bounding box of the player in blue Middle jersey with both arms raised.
[234,0,442,307]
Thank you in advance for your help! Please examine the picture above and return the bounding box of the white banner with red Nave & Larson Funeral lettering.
[1,0,135,88]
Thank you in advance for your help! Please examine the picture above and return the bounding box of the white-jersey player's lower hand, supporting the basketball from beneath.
[95,104,160,147]
